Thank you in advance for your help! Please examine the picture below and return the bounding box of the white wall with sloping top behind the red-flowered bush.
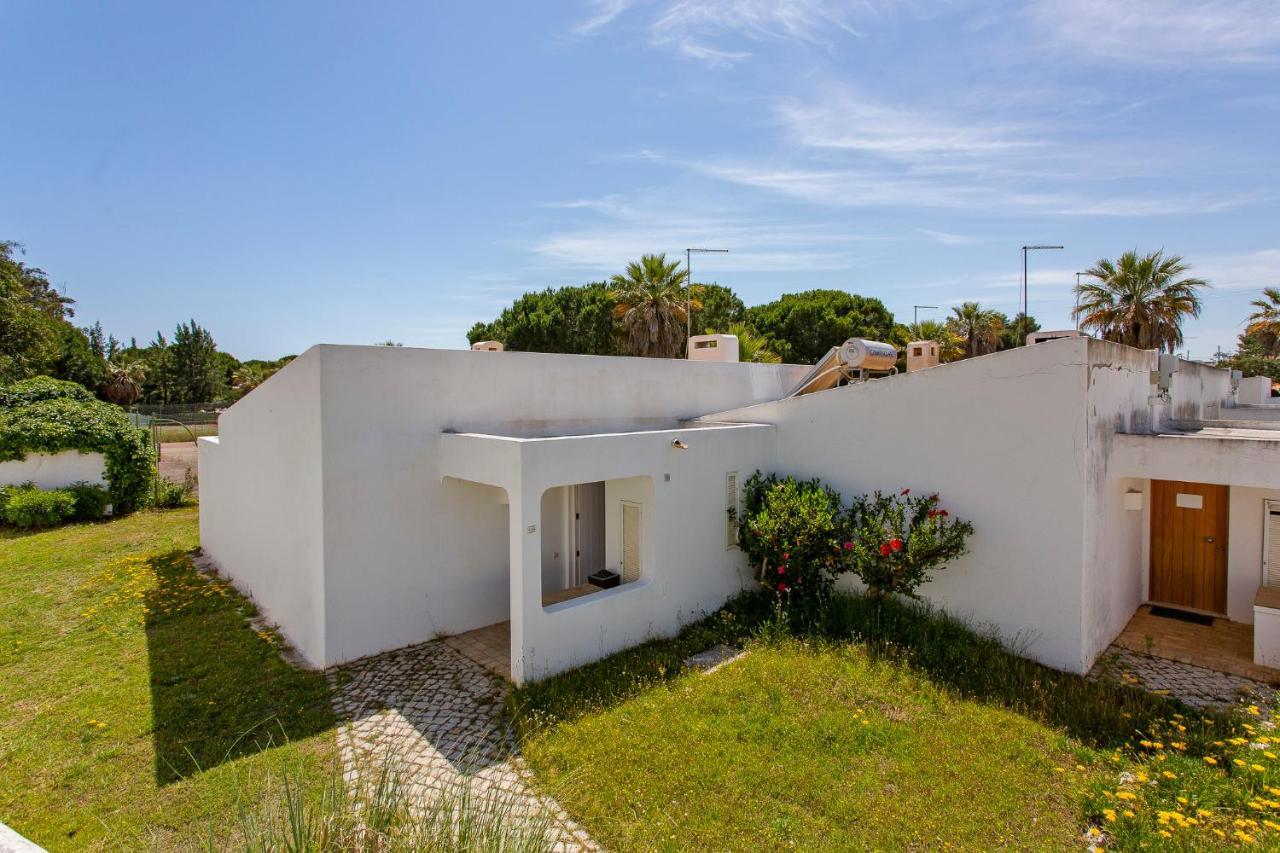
[708,338,1088,671]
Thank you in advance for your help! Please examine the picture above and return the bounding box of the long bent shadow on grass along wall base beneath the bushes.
[507,593,1228,754]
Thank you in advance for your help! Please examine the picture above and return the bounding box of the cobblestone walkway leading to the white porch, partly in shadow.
[329,642,599,850]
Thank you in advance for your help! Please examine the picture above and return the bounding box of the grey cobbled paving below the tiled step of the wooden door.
[1089,646,1277,708]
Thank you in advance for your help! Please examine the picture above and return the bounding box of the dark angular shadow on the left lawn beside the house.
[140,552,334,784]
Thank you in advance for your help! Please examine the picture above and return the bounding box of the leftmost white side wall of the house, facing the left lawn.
[197,350,329,666]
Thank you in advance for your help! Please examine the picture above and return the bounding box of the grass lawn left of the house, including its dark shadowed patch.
[0,508,334,850]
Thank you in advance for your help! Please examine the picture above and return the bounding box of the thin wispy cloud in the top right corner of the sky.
[1028,0,1280,67]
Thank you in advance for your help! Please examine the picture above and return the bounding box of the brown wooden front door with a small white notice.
[1149,480,1228,613]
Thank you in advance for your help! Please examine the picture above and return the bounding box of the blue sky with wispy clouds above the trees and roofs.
[0,0,1280,357]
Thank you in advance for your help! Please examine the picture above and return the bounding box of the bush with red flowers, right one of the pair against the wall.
[842,489,973,598]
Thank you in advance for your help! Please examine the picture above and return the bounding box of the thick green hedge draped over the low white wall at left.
[0,377,155,512]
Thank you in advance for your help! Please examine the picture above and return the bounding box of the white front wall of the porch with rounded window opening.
[440,424,774,683]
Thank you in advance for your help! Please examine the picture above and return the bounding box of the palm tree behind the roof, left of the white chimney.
[609,255,701,359]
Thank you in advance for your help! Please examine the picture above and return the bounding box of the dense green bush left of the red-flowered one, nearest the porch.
[739,471,847,606]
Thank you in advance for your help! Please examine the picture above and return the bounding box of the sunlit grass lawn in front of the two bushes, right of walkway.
[525,640,1082,849]
